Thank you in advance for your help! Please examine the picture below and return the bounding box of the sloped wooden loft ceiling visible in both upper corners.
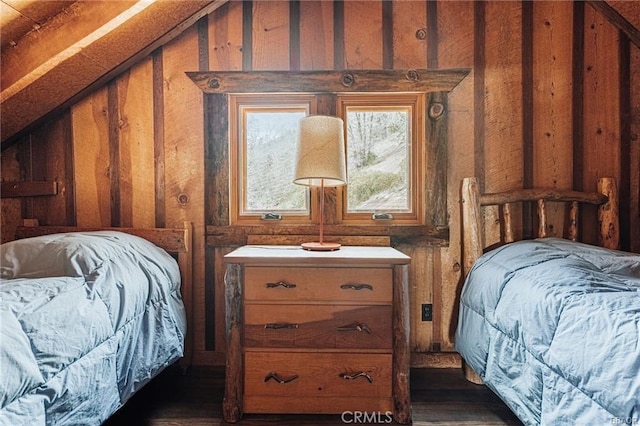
[0,0,640,146]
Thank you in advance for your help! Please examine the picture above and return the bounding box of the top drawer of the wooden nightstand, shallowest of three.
[244,267,393,303]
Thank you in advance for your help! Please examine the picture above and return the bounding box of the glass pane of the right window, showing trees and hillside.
[346,107,411,213]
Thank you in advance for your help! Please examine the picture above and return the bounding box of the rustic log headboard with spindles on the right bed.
[461,177,620,276]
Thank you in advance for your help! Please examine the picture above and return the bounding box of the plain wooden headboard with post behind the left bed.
[15,219,193,368]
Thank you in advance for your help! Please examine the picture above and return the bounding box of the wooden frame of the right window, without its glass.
[336,92,427,225]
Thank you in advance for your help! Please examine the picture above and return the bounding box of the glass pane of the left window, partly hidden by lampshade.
[243,108,308,213]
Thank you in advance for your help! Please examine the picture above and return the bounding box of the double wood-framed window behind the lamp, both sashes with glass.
[229,93,425,225]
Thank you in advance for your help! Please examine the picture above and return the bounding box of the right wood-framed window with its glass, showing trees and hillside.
[338,94,424,223]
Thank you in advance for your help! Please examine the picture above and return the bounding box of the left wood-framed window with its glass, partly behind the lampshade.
[230,95,315,223]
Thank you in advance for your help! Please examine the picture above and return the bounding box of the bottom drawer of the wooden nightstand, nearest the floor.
[244,351,392,399]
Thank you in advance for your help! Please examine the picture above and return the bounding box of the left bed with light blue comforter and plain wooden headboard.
[0,223,192,425]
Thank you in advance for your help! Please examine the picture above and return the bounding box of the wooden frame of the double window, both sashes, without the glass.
[229,92,427,226]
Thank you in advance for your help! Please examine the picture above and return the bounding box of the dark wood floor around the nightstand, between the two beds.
[103,367,522,426]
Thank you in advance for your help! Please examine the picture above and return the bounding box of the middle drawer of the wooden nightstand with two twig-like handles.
[244,303,392,351]
